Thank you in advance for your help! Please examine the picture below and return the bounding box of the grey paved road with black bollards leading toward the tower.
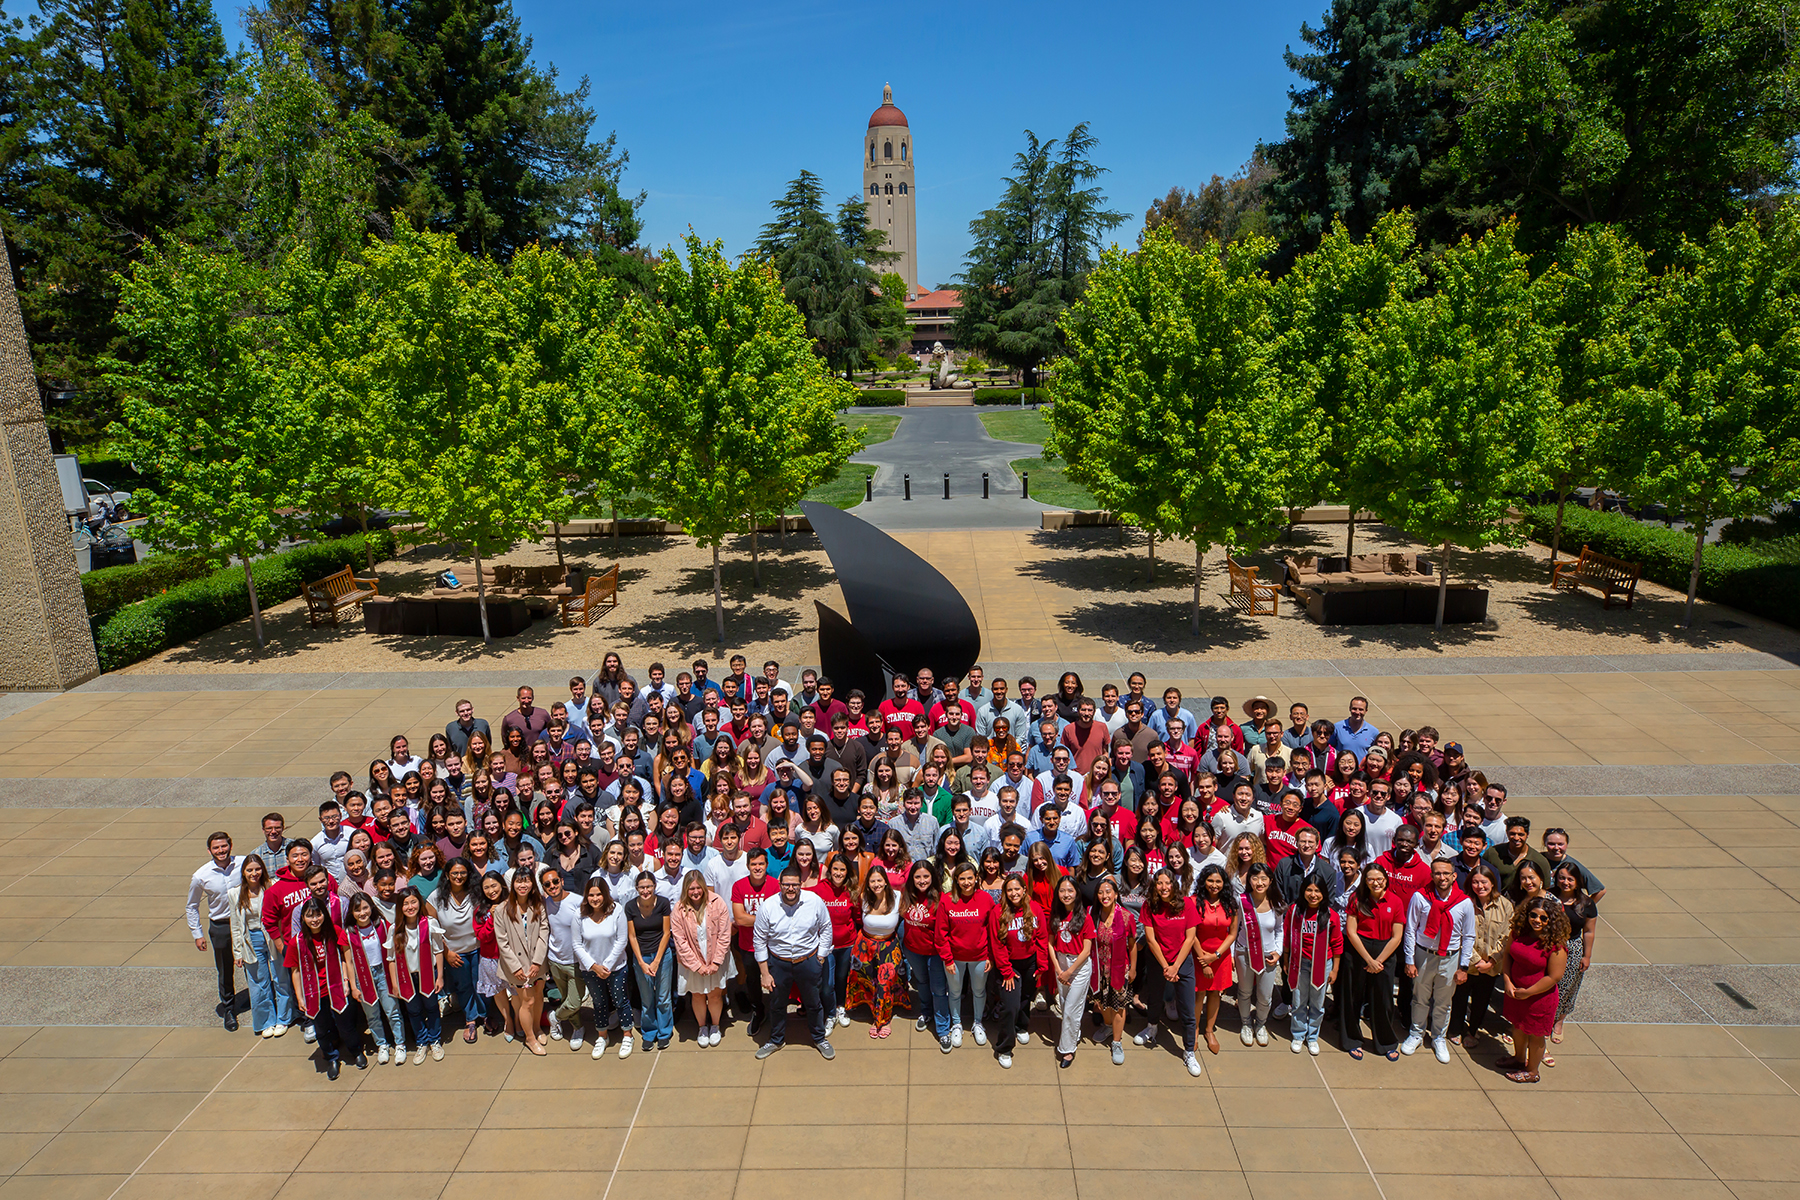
[851,408,1048,529]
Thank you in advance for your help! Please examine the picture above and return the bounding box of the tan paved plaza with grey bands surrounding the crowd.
[0,646,1800,1200]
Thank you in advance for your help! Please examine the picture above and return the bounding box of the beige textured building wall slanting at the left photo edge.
[0,239,101,691]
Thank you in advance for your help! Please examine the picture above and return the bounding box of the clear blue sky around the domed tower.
[182,0,1327,286]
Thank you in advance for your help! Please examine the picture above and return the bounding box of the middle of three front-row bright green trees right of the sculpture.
[1350,221,1557,630]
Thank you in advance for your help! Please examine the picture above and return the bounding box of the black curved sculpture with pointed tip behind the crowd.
[799,502,981,707]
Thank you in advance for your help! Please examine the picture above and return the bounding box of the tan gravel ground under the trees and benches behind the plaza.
[116,525,1800,675]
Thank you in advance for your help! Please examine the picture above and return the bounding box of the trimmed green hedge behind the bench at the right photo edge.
[1523,504,1800,628]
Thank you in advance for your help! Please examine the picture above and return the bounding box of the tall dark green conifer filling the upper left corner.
[0,0,230,437]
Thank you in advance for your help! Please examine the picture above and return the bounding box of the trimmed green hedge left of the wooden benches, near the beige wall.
[94,529,394,671]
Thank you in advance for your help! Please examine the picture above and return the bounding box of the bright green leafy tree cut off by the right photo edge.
[1624,203,1800,624]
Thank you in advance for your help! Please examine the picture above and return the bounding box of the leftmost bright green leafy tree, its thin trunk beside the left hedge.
[103,245,311,646]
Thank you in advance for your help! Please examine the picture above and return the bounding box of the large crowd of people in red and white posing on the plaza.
[187,653,1606,1083]
